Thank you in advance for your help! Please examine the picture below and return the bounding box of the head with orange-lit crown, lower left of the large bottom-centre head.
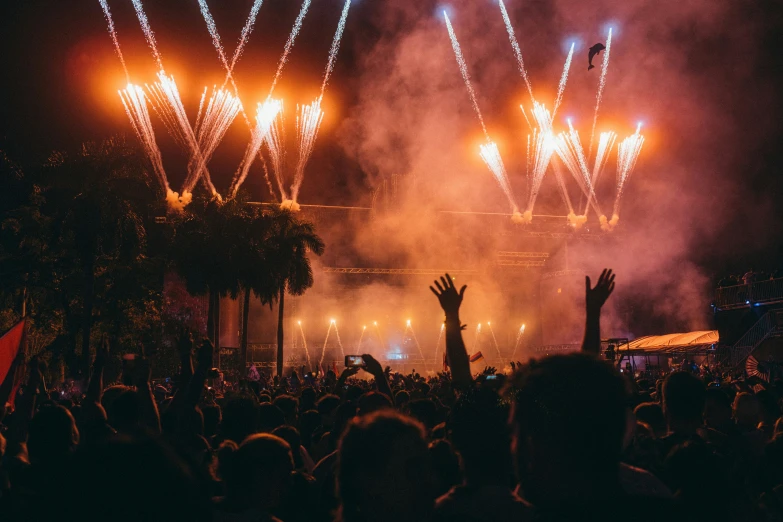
[218,433,294,510]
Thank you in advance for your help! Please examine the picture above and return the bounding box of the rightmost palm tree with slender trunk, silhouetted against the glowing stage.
[267,210,324,376]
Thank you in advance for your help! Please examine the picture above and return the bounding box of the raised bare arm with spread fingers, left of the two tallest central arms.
[430,274,473,386]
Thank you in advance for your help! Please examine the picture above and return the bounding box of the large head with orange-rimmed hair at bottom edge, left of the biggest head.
[337,410,435,522]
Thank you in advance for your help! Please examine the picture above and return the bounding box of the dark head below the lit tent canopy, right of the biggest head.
[663,372,706,433]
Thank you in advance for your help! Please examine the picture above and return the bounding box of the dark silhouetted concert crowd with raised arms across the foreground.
[0,271,783,522]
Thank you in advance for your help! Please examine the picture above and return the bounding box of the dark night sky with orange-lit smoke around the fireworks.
[0,0,783,280]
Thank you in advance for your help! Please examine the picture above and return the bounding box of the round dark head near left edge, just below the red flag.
[27,405,79,465]
